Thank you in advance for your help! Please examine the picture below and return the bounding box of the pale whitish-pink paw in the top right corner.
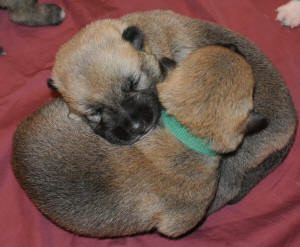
[276,0,300,28]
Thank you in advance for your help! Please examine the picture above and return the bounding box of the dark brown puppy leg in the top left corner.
[7,0,65,26]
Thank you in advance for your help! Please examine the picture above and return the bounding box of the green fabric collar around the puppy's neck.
[161,110,216,156]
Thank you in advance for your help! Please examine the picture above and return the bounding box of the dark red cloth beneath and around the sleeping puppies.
[0,0,300,247]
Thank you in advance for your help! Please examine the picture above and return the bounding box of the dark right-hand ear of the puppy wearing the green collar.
[245,111,269,135]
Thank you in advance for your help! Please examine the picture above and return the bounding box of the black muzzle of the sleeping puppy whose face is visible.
[95,89,161,145]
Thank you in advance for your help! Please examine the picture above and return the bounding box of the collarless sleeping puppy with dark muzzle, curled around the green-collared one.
[48,10,297,213]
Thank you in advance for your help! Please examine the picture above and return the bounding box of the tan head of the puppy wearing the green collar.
[157,46,265,153]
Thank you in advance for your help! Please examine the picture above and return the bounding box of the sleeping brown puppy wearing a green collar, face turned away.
[13,46,264,237]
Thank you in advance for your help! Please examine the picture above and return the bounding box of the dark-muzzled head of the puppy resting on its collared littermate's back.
[52,19,163,144]
